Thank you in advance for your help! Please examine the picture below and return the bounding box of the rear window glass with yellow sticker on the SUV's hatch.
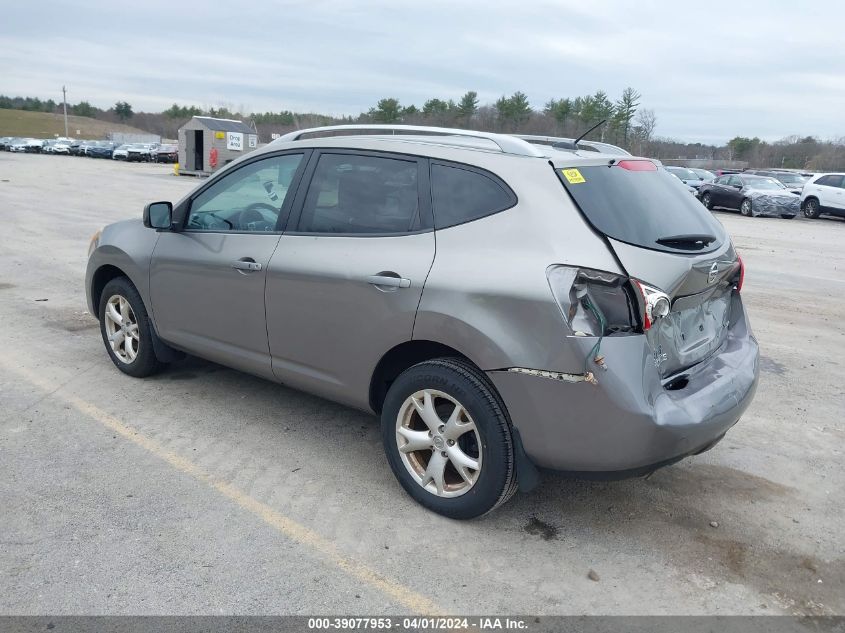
[556,161,726,252]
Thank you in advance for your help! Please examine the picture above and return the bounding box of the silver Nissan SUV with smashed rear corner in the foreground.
[85,126,758,519]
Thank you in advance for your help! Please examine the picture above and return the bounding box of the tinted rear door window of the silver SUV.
[297,154,419,235]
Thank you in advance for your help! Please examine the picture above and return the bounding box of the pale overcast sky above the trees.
[0,0,845,144]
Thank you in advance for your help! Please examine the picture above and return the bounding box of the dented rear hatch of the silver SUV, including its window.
[555,159,741,378]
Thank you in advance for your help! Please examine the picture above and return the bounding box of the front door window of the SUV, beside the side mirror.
[185,154,302,233]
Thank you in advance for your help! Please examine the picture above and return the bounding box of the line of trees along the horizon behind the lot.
[0,87,845,171]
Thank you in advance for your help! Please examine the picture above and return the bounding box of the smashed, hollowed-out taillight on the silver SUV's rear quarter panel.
[546,266,637,336]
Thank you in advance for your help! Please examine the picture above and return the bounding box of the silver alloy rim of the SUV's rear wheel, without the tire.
[396,389,482,497]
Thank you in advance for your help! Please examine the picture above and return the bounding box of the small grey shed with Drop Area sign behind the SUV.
[179,116,258,176]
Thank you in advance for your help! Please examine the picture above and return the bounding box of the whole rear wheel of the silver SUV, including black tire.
[381,358,517,519]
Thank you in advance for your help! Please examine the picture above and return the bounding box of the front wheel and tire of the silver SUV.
[97,277,164,378]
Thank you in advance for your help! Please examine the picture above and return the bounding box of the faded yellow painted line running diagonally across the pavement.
[0,359,445,615]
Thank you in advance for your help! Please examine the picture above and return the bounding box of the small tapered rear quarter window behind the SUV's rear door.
[431,163,516,229]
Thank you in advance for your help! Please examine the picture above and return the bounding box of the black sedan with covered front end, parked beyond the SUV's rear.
[698,174,800,218]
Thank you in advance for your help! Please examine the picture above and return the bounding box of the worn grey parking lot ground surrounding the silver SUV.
[0,153,845,615]
